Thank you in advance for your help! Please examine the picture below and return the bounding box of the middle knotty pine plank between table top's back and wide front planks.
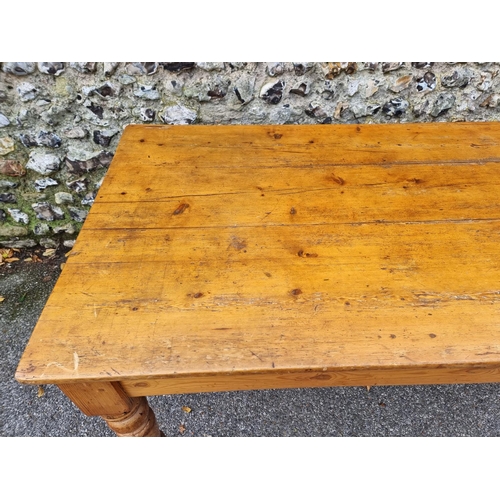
[84,164,500,229]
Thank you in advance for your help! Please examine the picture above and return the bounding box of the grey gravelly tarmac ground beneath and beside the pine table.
[0,250,500,437]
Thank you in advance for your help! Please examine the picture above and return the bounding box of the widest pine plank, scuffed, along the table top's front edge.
[16,223,500,383]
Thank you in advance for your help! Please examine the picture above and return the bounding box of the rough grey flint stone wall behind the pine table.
[0,62,500,248]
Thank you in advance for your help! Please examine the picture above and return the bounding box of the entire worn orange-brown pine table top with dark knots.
[16,123,500,392]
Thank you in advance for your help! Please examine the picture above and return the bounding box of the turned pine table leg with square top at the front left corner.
[58,382,163,437]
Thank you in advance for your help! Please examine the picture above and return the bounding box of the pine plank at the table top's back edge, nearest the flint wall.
[110,122,500,170]
